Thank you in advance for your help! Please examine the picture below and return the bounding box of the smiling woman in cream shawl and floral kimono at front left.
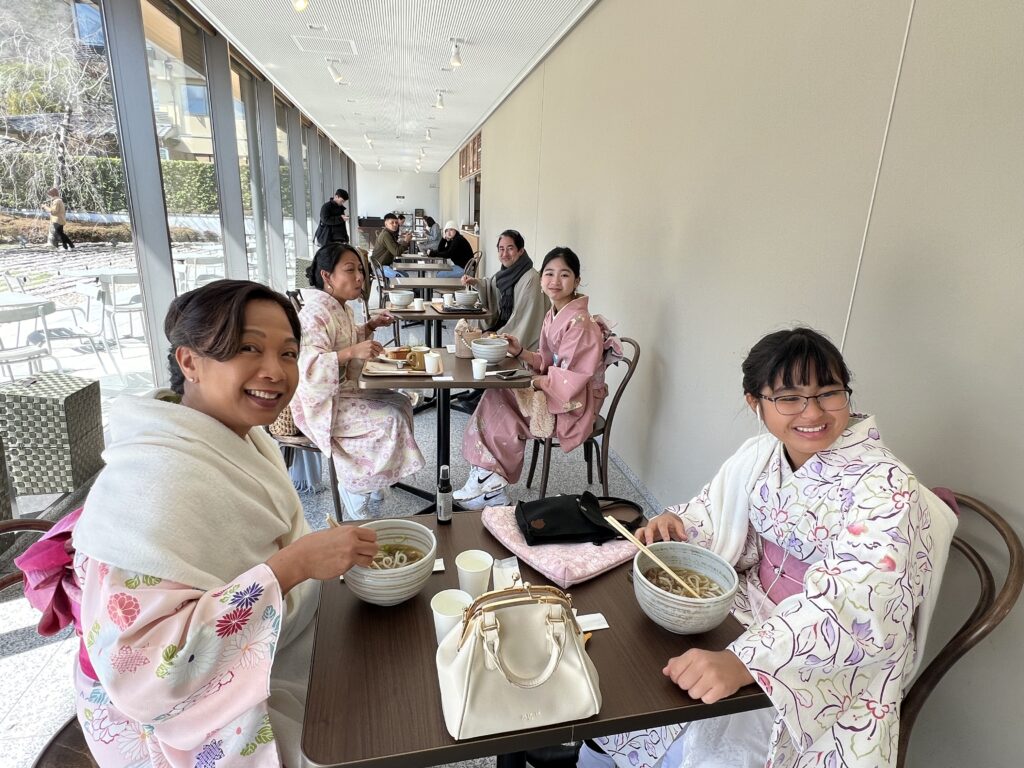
[74,281,377,768]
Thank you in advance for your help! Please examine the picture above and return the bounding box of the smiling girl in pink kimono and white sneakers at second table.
[454,247,608,509]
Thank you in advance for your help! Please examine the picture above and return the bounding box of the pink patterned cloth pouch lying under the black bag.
[481,507,637,589]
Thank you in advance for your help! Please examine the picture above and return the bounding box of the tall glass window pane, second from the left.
[142,0,224,293]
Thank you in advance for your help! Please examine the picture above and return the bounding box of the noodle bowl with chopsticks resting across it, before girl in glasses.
[633,542,739,635]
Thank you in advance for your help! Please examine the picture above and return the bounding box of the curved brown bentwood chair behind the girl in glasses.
[896,492,1024,768]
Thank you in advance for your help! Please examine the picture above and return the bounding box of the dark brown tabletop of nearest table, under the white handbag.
[302,512,770,768]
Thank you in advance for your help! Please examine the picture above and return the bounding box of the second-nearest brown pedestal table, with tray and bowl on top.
[358,347,532,505]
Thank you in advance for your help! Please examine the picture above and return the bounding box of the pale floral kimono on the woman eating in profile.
[291,291,423,494]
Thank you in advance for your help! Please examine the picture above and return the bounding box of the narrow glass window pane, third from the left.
[231,65,270,285]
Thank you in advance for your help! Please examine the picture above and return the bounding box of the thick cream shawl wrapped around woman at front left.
[74,390,309,610]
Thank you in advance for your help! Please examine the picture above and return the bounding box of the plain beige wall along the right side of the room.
[441,0,1024,768]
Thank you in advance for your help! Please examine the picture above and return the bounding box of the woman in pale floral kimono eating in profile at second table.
[292,243,423,520]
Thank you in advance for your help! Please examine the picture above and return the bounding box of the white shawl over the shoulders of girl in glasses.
[692,434,956,686]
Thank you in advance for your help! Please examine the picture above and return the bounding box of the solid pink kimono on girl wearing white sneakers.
[462,296,608,482]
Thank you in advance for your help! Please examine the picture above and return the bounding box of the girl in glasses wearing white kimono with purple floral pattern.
[581,328,955,768]
